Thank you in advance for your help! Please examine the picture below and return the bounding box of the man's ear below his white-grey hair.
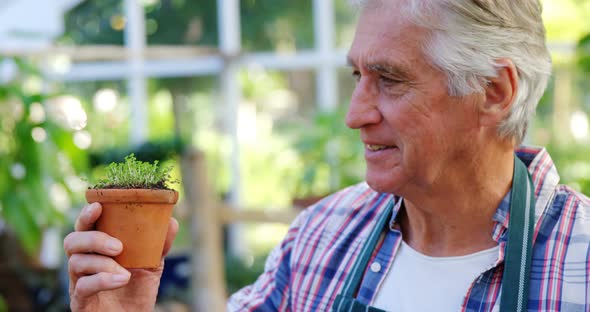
[479,58,518,127]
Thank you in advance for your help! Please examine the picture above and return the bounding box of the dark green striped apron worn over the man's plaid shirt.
[332,155,535,312]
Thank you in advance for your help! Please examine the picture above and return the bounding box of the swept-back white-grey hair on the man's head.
[351,0,551,144]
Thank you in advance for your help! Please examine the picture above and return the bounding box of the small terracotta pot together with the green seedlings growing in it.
[86,154,178,269]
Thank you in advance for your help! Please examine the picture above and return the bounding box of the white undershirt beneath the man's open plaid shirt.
[371,242,499,312]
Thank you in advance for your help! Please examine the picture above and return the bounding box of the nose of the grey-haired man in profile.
[346,77,381,129]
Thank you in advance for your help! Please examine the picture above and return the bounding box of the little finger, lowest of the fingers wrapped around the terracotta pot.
[74,272,131,301]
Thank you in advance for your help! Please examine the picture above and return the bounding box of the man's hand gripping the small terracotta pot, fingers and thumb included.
[64,203,178,311]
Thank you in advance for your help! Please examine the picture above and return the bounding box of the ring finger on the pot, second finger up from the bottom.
[68,254,130,279]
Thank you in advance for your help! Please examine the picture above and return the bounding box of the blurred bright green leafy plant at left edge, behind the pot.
[0,58,87,256]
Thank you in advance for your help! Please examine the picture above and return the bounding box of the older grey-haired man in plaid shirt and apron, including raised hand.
[65,0,590,312]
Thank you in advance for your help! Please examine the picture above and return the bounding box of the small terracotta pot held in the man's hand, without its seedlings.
[86,189,178,269]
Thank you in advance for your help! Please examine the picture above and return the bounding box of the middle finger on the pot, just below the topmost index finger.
[64,231,123,257]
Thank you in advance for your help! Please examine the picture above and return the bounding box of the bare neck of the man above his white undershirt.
[398,144,514,257]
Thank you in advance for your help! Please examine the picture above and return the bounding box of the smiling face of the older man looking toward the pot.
[346,1,481,196]
